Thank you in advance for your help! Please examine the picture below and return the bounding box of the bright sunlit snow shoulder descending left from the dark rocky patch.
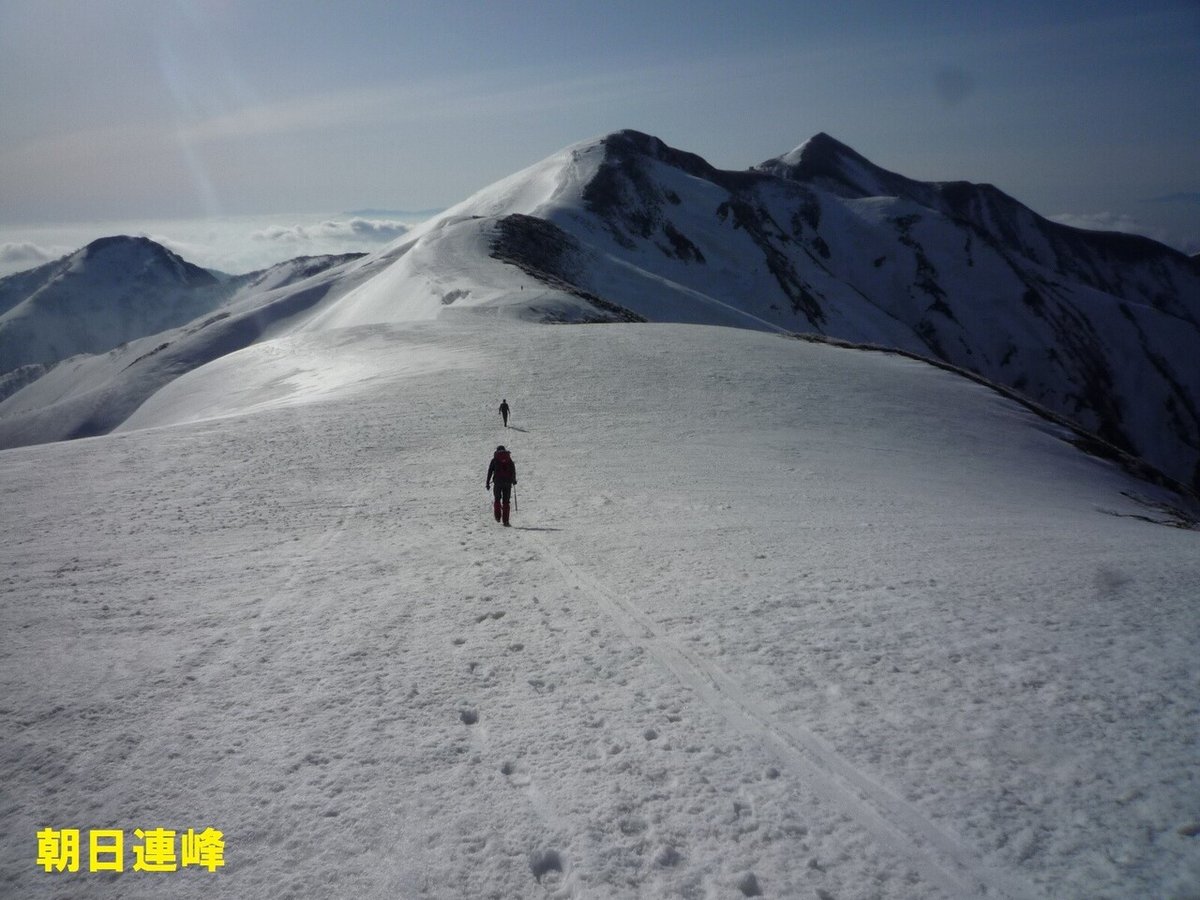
[0,216,612,448]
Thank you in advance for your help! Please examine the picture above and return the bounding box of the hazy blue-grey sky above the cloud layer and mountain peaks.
[0,0,1200,271]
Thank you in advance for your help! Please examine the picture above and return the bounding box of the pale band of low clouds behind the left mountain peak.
[0,210,432,277]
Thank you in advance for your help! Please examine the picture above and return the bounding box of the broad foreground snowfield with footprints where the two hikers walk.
[0,312,1200,900]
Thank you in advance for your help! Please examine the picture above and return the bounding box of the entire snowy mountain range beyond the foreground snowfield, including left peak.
[0,131,1200,490]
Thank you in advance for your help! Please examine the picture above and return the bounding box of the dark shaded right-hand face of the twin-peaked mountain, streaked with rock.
[523,132,1200,487]
